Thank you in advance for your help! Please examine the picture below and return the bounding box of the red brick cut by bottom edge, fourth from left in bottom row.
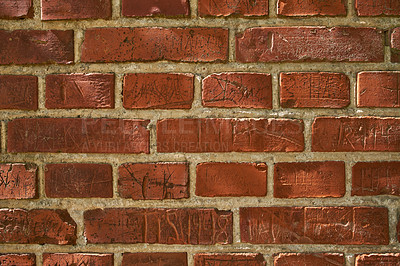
[194,253,267,266]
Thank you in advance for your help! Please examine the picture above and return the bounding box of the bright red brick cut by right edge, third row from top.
[357,71,400,107]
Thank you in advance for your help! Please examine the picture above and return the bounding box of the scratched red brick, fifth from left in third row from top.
[280,72,350,108]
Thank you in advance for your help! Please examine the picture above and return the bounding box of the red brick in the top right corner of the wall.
[355,0,400,16]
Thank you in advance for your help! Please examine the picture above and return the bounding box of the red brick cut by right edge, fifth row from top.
[351,162,400,196]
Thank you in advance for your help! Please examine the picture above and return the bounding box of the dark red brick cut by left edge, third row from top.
[0,75,38,110]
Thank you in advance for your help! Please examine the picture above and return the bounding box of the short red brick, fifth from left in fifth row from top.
[274,161,346,198]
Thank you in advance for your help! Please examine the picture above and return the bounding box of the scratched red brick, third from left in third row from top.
[124,73,194,109]
